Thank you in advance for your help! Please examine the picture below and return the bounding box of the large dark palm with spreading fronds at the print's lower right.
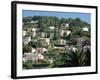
[67,50,90,67]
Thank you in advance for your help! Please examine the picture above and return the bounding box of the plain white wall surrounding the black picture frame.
[0,0,100,80]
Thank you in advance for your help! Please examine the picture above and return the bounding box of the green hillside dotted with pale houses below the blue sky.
[22,16,91,69]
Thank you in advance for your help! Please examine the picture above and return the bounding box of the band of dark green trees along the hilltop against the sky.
[23,16,90,28]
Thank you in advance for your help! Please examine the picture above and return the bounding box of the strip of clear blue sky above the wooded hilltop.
[22,10,91,24]
